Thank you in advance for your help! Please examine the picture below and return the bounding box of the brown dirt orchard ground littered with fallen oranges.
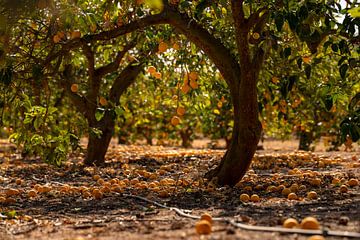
[0,141,360,240]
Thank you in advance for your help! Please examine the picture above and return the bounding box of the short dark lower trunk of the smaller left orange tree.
[84,115,115,166]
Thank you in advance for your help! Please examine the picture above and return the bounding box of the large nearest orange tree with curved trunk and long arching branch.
[105,0,356,185]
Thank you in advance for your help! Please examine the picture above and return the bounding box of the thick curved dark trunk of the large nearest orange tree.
[205,72,262,186]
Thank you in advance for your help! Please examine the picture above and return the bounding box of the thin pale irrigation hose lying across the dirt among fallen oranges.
[123,194,360,239]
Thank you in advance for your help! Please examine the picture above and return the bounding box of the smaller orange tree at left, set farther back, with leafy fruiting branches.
[1,1,156,165]
